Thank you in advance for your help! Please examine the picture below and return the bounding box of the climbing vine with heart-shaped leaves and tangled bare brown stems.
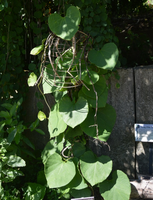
[28,1,130,200]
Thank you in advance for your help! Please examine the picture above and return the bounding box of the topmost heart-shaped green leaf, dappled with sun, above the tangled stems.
[48,6,81,40]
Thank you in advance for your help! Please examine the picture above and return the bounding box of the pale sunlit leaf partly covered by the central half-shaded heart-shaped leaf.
[48,103,67,138]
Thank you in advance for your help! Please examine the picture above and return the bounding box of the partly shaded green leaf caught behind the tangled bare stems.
[42,64,66,94]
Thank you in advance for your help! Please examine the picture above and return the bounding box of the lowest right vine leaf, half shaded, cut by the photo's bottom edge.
[99,170,131,200]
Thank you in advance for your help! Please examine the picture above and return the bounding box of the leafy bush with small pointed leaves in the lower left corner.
[0,99,45,200]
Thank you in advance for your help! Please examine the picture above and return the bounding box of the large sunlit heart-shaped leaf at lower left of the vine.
[44,153,76,188]
